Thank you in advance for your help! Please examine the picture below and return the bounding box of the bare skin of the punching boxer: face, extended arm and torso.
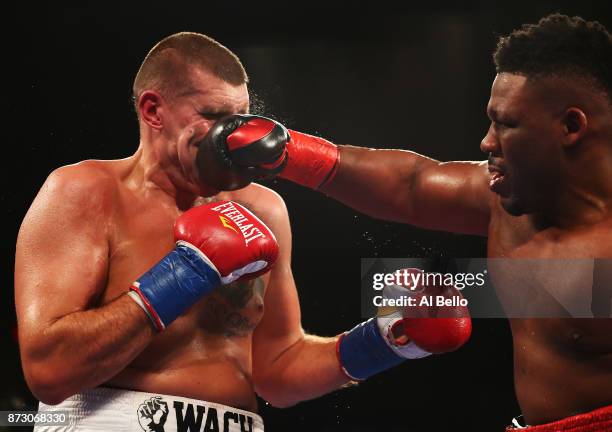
[322,73,612,425]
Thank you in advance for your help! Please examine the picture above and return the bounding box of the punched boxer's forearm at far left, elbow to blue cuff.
[21,295,155,404]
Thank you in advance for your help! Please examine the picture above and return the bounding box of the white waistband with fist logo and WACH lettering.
[34,387,264,432]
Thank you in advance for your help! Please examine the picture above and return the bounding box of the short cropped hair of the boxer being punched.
[132,32,249,112]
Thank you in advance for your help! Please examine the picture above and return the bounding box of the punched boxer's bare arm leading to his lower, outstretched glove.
[253,187,349,407]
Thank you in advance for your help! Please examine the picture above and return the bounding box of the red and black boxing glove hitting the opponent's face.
[196,114,339,190]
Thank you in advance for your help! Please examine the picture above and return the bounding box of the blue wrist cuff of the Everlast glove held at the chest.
[130,243,221,331]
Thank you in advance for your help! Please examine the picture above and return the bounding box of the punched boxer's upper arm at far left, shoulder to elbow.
[15,167,109,338]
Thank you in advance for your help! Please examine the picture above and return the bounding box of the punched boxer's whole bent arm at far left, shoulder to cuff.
[15,166,154,404]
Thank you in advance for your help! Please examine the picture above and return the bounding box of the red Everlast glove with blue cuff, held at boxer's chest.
[130,201,278,331]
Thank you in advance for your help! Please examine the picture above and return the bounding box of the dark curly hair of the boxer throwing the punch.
[493,13,612,101]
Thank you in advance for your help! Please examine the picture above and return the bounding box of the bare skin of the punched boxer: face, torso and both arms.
[15,66,348,411]
